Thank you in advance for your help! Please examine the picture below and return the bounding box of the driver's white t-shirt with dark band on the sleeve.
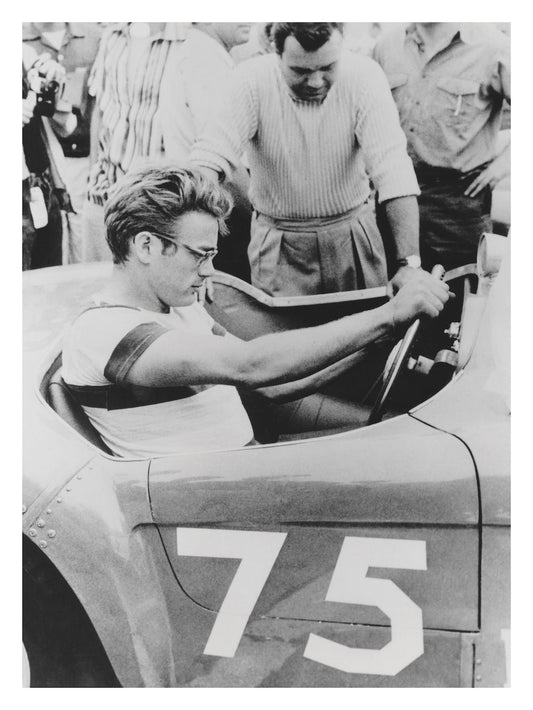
[62,303,253,457]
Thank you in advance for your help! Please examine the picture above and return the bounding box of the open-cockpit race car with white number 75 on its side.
[23,235,510,687]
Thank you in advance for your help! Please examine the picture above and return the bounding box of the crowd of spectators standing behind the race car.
[22,22,510,295]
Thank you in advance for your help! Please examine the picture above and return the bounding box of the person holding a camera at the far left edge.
[22,45,76,270]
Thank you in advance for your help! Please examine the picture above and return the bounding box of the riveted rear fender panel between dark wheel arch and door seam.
[24,457,175,687]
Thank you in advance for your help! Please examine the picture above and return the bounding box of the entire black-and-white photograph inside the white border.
[18,11,512,703]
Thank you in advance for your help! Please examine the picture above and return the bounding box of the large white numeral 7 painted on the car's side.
[177,528,287,658]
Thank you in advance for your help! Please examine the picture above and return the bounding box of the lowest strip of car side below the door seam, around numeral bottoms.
[161,610,470,688]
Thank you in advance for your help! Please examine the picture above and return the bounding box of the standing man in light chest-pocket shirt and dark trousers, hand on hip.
[374,22,511,270]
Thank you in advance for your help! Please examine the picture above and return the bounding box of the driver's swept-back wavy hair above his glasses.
[104,165,232,264]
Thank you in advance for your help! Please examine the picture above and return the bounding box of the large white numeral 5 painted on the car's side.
[304,537,427,676]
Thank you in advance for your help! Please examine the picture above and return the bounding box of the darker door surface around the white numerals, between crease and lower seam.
[161,525,479,631]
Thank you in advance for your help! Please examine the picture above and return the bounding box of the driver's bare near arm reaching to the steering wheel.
[125,272,448,388]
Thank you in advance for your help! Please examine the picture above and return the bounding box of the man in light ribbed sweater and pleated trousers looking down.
[191,23,419,295]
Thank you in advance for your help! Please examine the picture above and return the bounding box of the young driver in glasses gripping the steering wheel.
[63,166,448,457]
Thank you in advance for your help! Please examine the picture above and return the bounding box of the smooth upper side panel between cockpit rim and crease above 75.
[150,416,478,525]
